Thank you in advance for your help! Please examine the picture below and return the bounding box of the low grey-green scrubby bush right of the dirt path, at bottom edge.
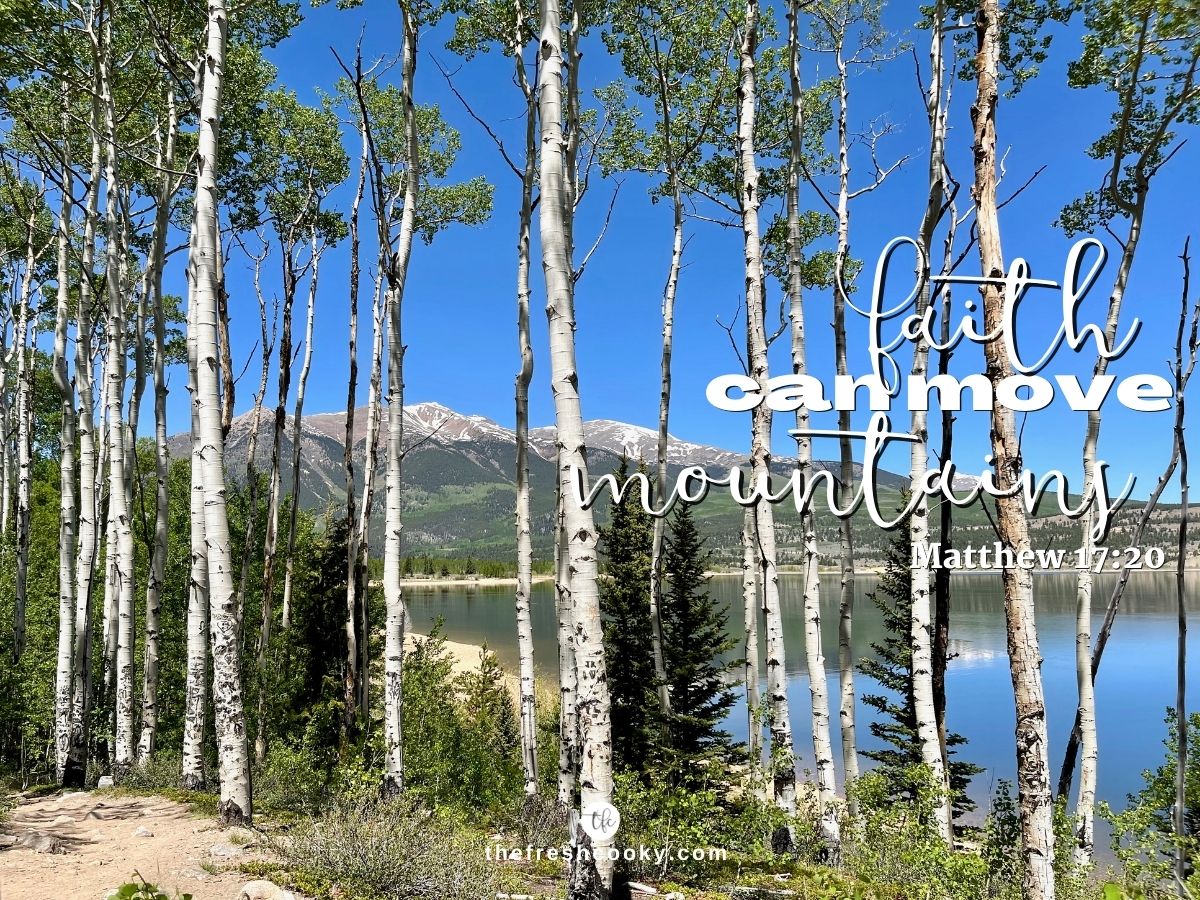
[272,797,496,900]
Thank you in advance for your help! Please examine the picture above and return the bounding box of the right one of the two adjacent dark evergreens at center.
[662,504,740,782]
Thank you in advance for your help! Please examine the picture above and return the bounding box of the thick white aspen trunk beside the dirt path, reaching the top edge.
[188,0,251,823]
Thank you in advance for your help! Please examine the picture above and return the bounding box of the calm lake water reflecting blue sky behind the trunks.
[404,572,1200,808]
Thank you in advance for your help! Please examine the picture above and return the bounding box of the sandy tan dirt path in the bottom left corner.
[0,792,271,900]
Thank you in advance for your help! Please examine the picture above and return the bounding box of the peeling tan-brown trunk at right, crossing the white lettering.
[971,0,1055,900]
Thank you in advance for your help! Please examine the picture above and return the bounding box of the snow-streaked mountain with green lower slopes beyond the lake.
[169,402,906,559]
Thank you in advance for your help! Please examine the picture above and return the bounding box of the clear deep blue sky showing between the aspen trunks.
[152,0,1196,504]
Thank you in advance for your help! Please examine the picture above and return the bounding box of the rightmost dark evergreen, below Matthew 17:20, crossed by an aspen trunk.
[858,508,983,818]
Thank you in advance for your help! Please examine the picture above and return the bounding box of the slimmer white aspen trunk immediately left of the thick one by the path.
[182,286,209,791]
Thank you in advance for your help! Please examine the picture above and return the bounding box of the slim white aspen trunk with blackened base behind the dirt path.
[62,81,101,787]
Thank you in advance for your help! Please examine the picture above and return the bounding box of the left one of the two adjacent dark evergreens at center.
[600,460,661,772]
